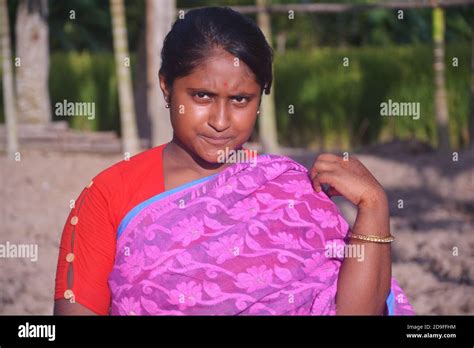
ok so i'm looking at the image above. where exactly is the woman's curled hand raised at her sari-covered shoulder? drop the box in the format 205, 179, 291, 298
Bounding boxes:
311, 154, 387, 207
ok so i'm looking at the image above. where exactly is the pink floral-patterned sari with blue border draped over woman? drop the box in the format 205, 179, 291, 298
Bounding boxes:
109, 155, 413, 315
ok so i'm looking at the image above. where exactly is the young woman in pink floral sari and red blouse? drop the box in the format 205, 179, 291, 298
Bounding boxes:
54, 8, 412, 315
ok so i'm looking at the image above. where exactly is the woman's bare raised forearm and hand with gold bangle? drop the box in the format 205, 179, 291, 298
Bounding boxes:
311, 154, 391, 315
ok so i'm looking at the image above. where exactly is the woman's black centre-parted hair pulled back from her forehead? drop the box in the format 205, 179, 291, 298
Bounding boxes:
160, 7, 273, 94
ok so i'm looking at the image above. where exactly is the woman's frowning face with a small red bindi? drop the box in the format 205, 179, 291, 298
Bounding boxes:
160, 50, 261, 163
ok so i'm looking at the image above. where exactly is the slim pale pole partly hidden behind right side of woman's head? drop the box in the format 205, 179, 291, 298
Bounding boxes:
257, 0, 279, 153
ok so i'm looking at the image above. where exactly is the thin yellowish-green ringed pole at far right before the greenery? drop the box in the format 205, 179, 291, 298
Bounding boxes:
433, 7, 450, 151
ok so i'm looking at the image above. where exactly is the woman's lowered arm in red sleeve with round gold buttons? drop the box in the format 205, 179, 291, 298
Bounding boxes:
54, 167, 121, 315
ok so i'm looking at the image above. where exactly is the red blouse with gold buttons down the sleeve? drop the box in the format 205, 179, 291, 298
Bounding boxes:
54, 144, 166, 315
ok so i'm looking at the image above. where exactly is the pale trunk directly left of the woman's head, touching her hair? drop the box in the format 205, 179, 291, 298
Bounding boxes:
146, 0, 176, 146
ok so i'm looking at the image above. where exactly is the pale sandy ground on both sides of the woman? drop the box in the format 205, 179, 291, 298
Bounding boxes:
0, 143, 474, 314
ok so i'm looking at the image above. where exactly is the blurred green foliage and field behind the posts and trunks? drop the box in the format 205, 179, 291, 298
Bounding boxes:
0, 0, 474, 148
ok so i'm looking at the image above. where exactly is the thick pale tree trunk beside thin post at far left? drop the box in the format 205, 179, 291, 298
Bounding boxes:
15, 0, 51, 125
